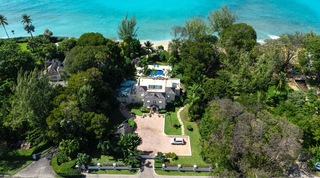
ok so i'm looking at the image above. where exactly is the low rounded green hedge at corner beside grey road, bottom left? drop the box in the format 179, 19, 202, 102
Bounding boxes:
51, 157, 81, 176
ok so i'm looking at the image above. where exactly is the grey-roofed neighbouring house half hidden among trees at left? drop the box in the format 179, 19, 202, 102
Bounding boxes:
45, 60, 63, 82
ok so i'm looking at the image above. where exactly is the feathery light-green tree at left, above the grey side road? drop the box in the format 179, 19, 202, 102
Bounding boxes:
7, 70, 54, 142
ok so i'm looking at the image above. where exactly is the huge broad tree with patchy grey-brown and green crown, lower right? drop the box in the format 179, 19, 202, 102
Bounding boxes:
200, 99, 302, 177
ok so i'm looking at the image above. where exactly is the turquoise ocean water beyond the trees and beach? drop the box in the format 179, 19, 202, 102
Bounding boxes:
0, 0, 320, 40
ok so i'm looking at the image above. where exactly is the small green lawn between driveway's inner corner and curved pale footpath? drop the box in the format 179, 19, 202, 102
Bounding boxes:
164, 108, 181, 135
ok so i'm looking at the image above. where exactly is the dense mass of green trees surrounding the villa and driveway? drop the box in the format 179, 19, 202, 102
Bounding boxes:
0, 6, 320, 177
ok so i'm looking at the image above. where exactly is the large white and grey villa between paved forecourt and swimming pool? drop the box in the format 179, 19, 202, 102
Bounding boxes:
117, 66, 180, 109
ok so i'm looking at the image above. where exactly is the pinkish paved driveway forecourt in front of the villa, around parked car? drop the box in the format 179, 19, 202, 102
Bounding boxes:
135, 114, 191, 156
